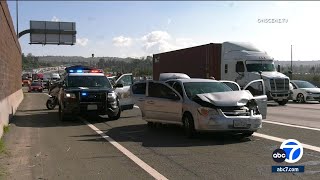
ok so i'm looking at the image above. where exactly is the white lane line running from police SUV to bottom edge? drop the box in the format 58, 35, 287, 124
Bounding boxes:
81, 118, 167, 180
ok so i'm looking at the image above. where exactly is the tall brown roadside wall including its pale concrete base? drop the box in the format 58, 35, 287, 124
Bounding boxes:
0, 0, 23, 138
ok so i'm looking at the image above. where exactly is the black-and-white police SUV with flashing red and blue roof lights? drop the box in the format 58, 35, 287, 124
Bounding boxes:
58, 66, 121, 121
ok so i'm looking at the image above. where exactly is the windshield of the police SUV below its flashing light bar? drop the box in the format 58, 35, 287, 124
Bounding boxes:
67, 76, 112, 88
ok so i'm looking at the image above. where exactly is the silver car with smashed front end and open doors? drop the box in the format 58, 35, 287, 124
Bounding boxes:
131, 78, 267, 137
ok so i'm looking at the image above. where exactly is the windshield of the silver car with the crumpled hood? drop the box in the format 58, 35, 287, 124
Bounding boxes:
183, 82, 232, 99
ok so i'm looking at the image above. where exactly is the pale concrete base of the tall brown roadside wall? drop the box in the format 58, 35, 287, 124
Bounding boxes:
0, 89, 23, 137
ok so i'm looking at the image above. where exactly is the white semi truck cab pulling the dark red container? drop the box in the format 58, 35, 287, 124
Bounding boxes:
221, 42, 290, 105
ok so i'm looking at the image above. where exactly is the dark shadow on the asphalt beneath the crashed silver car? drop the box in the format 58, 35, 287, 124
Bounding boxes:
76, 124, 251, 147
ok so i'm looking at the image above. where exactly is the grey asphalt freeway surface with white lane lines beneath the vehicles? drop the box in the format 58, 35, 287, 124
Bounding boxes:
0, 90, 320, 180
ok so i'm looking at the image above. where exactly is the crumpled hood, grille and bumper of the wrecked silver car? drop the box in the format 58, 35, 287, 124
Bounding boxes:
194, 91, 262, 132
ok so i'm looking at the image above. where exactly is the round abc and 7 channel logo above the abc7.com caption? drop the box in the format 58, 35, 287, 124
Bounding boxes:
272, 139, 303, 163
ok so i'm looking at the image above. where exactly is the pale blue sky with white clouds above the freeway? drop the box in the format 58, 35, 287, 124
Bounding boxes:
8, 1, 320, 60
